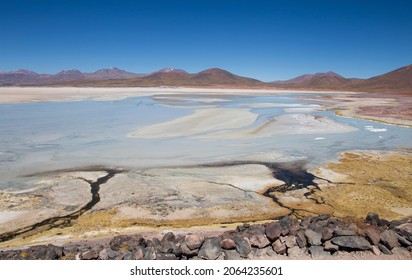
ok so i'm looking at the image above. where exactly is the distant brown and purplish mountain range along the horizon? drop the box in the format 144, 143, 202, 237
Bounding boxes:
0, 65, 412, 94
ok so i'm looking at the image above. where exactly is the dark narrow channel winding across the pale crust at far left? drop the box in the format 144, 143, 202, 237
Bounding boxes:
0, 169, 123, 242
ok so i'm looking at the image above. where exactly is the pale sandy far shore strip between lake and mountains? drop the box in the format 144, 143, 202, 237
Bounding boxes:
0, 86, 412, 127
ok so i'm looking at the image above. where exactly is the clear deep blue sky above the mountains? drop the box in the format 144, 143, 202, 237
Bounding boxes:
0, 0, 412, 81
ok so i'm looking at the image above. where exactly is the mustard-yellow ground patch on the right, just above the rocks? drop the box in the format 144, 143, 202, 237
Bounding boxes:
322, 152, 412, 219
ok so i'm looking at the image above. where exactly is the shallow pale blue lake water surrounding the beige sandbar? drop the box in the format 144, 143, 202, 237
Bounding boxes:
0, 93, 412, 189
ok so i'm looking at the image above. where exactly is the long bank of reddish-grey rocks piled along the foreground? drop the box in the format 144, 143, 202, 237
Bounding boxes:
0, 213, 412, 260
